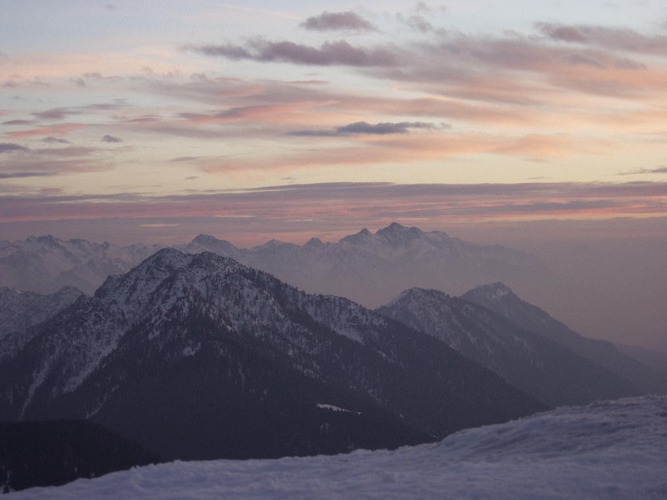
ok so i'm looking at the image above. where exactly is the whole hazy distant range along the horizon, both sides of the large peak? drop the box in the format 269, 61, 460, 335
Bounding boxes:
0, 223, 553, 307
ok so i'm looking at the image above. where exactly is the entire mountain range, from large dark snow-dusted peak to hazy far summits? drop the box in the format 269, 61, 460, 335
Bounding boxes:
0, 224, 667, 459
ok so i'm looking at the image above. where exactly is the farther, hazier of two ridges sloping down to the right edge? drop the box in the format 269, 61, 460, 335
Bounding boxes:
462, 283, 667, 393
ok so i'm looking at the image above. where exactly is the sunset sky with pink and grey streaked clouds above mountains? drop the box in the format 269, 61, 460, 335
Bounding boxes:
0, 0, 667, 352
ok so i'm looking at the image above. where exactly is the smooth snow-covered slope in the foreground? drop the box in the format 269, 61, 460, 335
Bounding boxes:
8, 396, 667, 499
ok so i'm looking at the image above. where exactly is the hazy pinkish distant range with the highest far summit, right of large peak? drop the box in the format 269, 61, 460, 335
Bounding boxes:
182, 223, 553, 307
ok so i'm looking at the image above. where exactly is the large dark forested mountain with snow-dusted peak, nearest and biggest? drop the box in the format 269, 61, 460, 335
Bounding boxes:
0, 249, 544, 459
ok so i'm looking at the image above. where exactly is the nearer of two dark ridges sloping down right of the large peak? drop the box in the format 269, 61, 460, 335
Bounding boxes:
378, 288, 639, 406
